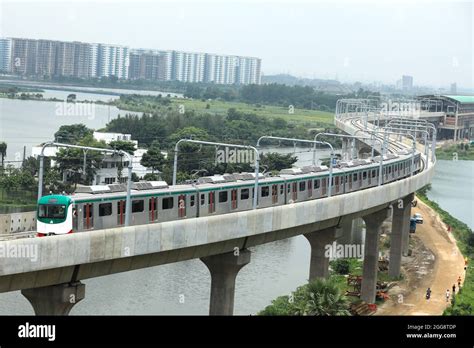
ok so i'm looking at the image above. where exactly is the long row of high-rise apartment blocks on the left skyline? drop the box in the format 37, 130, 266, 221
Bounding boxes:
0, 38, 261, 84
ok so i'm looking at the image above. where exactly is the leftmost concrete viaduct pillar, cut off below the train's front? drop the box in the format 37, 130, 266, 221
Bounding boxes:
21, 282, 86, 315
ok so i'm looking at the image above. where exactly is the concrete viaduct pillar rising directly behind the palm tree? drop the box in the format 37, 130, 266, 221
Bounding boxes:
304, 227, 336, 281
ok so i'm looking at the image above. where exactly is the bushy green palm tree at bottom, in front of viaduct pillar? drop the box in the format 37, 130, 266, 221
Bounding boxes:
290, 278, 350, 316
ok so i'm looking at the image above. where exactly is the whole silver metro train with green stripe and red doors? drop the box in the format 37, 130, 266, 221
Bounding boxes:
37, 149, 423, 236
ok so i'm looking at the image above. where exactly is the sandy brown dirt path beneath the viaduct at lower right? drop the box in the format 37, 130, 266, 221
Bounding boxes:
376, 200, 465, 315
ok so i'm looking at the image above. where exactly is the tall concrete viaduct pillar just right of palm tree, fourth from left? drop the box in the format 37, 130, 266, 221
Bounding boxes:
360, 209, 388, 303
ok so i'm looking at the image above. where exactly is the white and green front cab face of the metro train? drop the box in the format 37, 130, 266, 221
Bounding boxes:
36, 195, 73, 237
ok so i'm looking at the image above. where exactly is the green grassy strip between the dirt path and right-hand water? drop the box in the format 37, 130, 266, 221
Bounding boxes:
416, 185, 474, 315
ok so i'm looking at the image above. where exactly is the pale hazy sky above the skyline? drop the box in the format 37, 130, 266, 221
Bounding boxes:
0, 0, 474, 89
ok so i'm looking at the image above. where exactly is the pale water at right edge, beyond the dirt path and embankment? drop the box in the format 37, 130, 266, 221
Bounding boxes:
428, 160, 474, 230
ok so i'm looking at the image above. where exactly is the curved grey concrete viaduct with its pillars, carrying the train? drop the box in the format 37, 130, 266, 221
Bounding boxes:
0, 105, 434, 315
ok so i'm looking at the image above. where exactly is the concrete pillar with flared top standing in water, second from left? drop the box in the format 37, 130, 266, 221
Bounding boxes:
201, 249, 250, 315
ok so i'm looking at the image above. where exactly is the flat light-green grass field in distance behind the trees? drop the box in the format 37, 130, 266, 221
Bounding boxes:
172, 98, 334, 124
